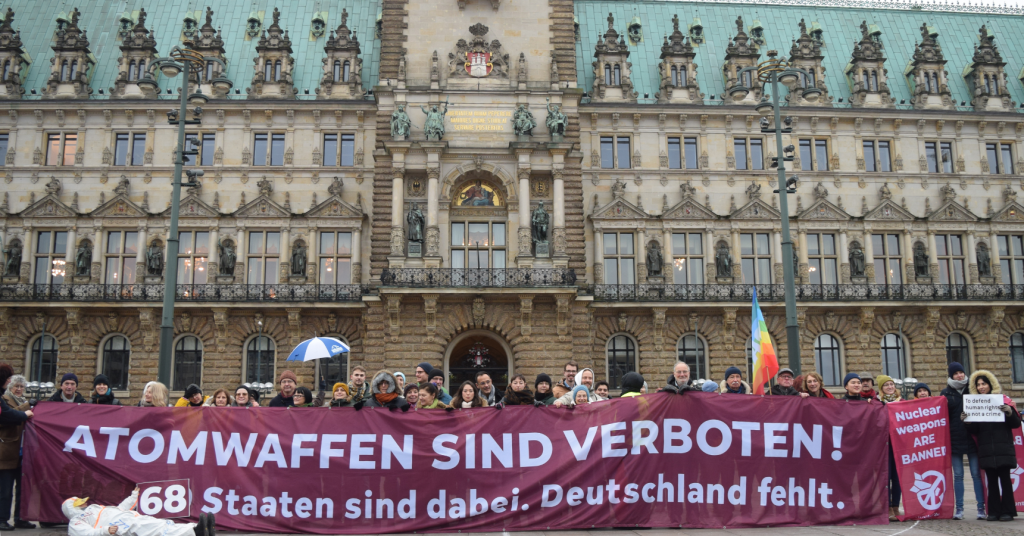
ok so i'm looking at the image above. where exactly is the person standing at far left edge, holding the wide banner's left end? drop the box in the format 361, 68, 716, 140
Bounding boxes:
0, 363, 36, 531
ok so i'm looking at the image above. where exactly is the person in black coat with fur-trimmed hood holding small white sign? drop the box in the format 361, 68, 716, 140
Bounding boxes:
961, 370, 1021, 521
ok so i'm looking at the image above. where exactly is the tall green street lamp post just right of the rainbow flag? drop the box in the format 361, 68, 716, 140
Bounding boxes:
739, 50, 821, 376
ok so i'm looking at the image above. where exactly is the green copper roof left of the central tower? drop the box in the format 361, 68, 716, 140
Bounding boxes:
2, 0, 380, 98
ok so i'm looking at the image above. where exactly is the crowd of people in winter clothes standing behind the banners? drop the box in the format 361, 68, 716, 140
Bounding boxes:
0, 361, 1021, 531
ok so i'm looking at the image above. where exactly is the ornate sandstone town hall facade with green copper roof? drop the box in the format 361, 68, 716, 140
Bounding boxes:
0, 0, 1024, 399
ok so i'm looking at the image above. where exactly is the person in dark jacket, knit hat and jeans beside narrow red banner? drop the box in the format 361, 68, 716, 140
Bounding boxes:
939, 361, 986, 520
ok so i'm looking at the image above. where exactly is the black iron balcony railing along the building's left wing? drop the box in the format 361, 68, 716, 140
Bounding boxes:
0, 284, 367, 303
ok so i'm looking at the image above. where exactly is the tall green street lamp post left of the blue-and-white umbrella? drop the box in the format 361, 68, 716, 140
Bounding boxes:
139, 41, 224, 384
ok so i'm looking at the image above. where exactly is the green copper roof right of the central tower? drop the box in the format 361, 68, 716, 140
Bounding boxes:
575, 0, 1024, 107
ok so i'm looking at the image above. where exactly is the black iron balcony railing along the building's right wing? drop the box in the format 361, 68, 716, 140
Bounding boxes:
594, 284, 1024, 302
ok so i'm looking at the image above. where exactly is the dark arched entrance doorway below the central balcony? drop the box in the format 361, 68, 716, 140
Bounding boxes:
444, 329, 512, 393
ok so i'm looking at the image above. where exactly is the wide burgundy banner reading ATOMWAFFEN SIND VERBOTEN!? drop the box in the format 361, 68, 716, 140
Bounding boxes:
23, 393, 888, 534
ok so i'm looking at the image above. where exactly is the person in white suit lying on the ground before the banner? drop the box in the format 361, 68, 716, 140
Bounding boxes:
60, 488, 216, 536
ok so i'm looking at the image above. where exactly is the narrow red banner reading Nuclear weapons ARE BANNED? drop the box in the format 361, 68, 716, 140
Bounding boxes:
886, 397, 959, 521
